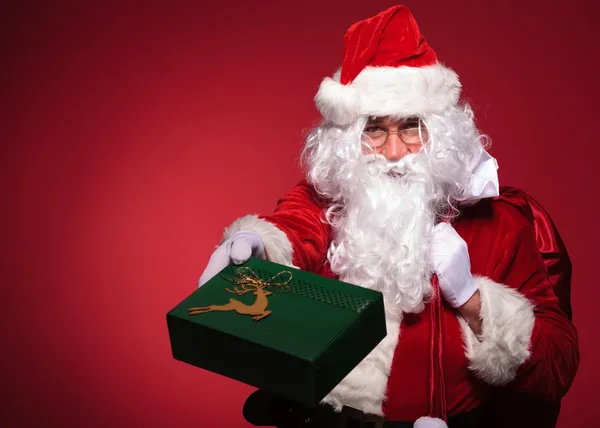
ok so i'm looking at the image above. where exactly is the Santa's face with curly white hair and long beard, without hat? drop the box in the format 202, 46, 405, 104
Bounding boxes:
303, 108, 482, 312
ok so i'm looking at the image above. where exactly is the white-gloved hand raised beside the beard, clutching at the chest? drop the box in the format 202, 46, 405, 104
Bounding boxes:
428, 223, 477, 308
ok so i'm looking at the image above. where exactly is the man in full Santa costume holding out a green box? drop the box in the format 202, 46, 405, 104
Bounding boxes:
200, 6, 579, 428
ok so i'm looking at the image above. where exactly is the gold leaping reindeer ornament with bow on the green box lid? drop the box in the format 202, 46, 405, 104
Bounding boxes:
188, 267, 292, 321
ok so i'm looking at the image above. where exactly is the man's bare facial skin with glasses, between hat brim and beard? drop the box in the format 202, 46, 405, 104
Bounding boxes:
362, 116, 427, 161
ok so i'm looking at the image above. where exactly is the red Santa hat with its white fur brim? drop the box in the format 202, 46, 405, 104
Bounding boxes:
315, 5, 461, 126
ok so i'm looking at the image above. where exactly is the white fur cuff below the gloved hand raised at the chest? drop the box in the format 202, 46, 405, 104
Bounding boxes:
459, 277, 535, 385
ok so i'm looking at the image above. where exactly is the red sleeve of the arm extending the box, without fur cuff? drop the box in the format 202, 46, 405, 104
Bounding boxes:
259, 180, 330, 273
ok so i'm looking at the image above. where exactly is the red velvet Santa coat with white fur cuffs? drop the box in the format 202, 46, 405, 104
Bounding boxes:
224, 181, 579, 427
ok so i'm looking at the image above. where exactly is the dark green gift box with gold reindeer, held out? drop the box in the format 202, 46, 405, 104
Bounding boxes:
167, 258, 386, 405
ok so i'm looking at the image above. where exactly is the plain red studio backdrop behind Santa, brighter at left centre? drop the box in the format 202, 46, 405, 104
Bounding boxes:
0, 0, 600, 427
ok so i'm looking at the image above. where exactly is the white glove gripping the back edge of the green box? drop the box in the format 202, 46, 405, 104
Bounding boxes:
198, 230, 265, 287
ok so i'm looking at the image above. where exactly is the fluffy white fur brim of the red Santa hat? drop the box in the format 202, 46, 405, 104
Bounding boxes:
315, 63, 461, 126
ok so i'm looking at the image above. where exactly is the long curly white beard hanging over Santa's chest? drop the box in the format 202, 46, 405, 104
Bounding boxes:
328, 154, 435, 315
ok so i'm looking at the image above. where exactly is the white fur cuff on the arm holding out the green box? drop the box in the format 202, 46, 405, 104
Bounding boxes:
222, 214, 296, 267
